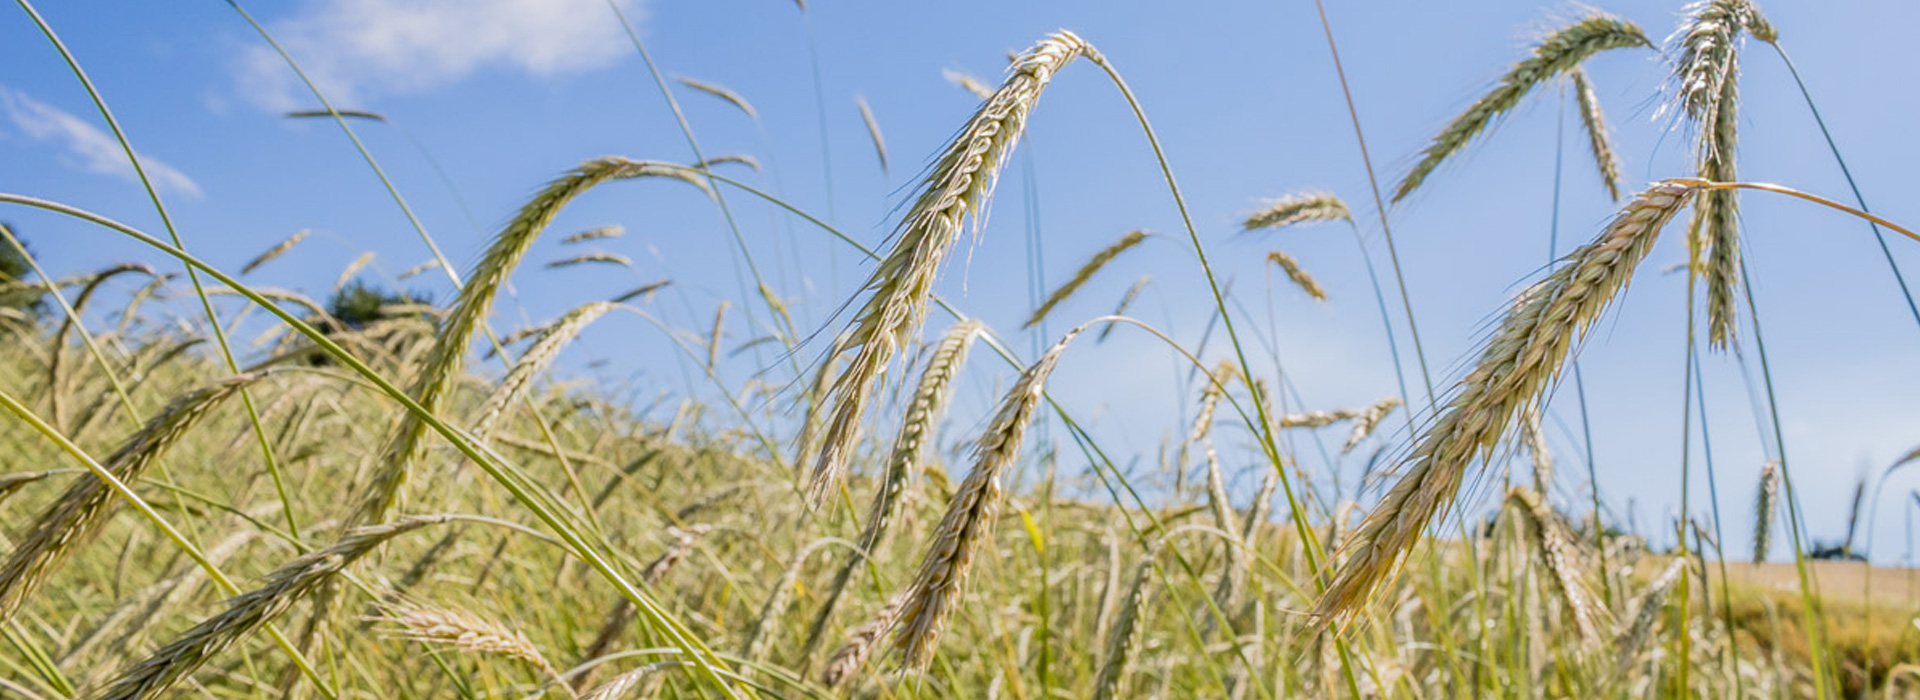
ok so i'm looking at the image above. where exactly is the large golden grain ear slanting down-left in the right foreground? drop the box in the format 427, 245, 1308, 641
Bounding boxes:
1317, 182, 1693, 616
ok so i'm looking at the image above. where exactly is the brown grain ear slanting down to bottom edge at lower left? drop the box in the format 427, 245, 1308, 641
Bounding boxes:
88, 516, 447, 700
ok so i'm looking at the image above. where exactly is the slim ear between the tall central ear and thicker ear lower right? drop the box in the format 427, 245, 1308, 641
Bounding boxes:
806, 320, 987, 648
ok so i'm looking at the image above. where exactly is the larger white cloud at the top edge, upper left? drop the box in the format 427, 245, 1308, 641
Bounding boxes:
238, 0, 639, 109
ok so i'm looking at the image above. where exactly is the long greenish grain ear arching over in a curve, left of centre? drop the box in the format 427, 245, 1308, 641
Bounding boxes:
348, 157, 710, 525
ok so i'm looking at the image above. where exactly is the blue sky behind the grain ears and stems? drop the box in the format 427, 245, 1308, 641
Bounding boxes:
0, 0, 1920, 560
